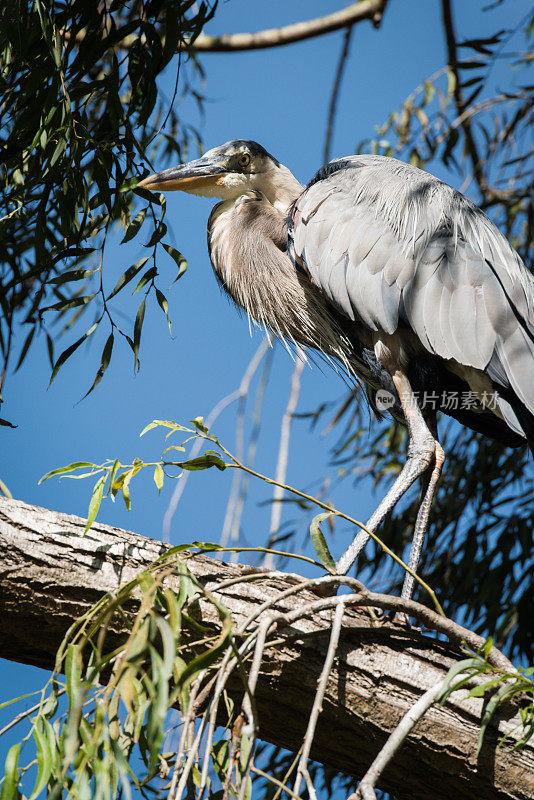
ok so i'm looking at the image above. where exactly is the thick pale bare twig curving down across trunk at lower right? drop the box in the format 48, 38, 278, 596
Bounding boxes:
347, 674, 468, 800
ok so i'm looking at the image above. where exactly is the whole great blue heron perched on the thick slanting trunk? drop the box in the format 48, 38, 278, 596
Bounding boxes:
138, 139, 534, 598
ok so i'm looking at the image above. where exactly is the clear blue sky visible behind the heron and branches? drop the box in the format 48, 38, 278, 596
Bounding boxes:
0, 0, 530, 780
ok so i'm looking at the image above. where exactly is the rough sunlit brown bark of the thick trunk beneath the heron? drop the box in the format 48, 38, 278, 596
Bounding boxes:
0, 499, 534, 800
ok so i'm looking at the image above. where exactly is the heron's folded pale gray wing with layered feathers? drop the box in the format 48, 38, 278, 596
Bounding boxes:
290, 156, 534, 424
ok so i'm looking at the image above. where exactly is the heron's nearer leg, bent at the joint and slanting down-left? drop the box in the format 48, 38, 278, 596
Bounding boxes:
336, 370, 443, 577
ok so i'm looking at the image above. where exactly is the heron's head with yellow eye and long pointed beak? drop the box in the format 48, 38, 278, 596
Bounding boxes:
137, 139, 302, 211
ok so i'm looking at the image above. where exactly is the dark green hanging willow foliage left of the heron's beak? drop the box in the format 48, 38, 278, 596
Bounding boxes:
0, 0, 208, 406
